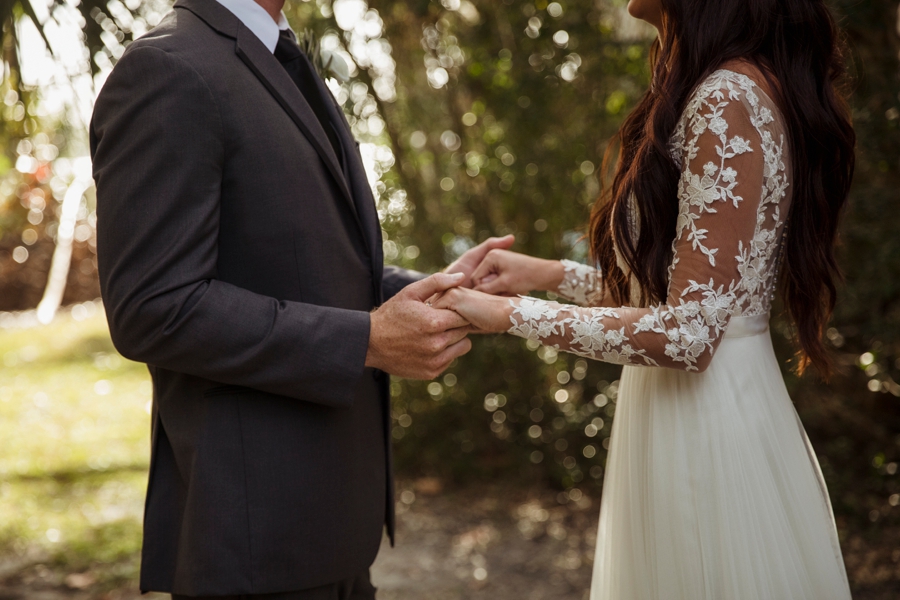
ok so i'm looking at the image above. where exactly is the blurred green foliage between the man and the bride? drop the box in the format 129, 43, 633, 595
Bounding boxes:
356, 1, 649, 487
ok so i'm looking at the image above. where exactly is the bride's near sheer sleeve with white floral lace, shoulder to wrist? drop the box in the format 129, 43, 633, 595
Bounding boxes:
509, 81, 771, 371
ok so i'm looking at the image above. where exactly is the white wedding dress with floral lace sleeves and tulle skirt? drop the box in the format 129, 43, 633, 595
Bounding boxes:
509, 70, 850, 600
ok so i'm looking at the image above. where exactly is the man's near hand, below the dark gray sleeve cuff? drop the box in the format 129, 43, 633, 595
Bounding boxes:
366, 273, 472, 379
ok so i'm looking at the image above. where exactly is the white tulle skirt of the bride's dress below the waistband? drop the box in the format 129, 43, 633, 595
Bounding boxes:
591, 316, 850, 600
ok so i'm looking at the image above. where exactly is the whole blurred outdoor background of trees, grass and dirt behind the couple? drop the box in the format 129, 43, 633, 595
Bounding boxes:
0, 0, 900, 600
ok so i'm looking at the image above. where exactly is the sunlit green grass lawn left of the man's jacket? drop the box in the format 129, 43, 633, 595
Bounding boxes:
0, 303, 151, 590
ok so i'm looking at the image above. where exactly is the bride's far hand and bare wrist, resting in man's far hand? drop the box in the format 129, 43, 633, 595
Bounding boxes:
472, 249, 565, 296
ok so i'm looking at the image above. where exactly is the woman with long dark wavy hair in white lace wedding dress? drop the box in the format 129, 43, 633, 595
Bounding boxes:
436, 0, 852, 600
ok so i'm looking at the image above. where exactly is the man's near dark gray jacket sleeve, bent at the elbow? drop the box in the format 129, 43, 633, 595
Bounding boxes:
91, 42, 369, 407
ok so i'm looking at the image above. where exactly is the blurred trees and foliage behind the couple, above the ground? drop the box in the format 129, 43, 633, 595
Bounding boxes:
0, 0, 900, 572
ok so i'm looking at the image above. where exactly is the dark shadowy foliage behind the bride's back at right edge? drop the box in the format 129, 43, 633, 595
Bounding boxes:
783, 0, 900, 540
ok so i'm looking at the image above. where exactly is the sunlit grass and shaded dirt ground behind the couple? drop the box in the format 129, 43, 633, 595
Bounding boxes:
0, 303, 900, 600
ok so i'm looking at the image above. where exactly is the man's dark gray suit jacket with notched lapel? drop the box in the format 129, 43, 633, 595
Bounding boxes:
91, 0, 419, 595
